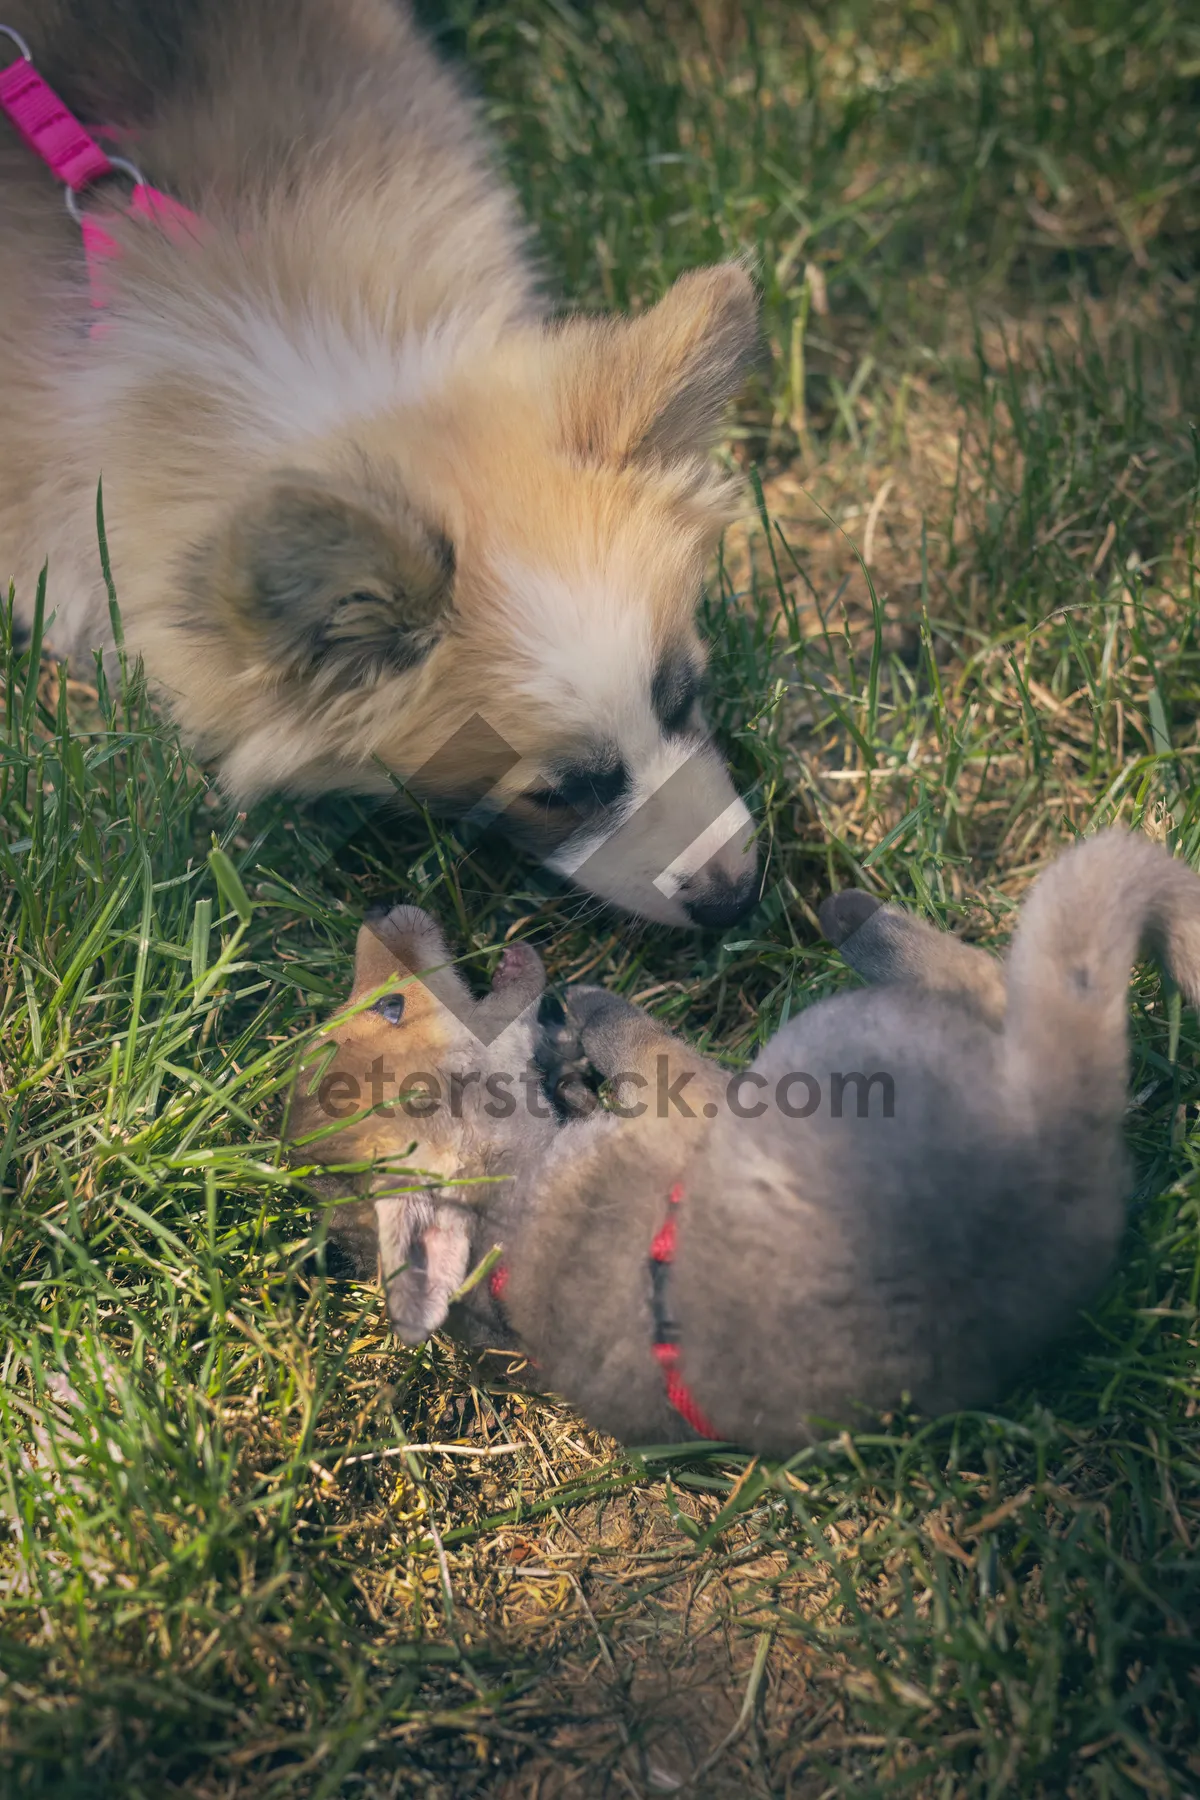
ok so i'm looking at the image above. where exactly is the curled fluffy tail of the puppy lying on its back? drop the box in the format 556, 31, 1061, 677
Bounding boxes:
1004, 830, 1200, 1136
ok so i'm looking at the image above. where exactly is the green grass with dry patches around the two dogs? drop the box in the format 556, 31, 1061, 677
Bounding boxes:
0, 0, 1200, 1800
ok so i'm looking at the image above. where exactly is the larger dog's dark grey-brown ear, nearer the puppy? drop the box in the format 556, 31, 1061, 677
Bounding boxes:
204, 473, 453, 688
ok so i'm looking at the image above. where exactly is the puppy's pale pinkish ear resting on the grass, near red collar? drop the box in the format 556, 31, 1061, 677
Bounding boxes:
374, 1193, 471, 1345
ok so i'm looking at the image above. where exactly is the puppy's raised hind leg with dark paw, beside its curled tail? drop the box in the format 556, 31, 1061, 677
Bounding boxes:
819, 887, 1004, 1028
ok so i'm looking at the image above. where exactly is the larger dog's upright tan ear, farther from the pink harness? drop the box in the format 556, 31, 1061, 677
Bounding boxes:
560, 263, 761, 466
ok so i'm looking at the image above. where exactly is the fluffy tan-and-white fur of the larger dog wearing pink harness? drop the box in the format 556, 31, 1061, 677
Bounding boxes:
0, 0, 756, 923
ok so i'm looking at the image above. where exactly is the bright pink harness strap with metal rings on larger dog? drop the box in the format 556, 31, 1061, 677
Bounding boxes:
0, 25, 205, 337
